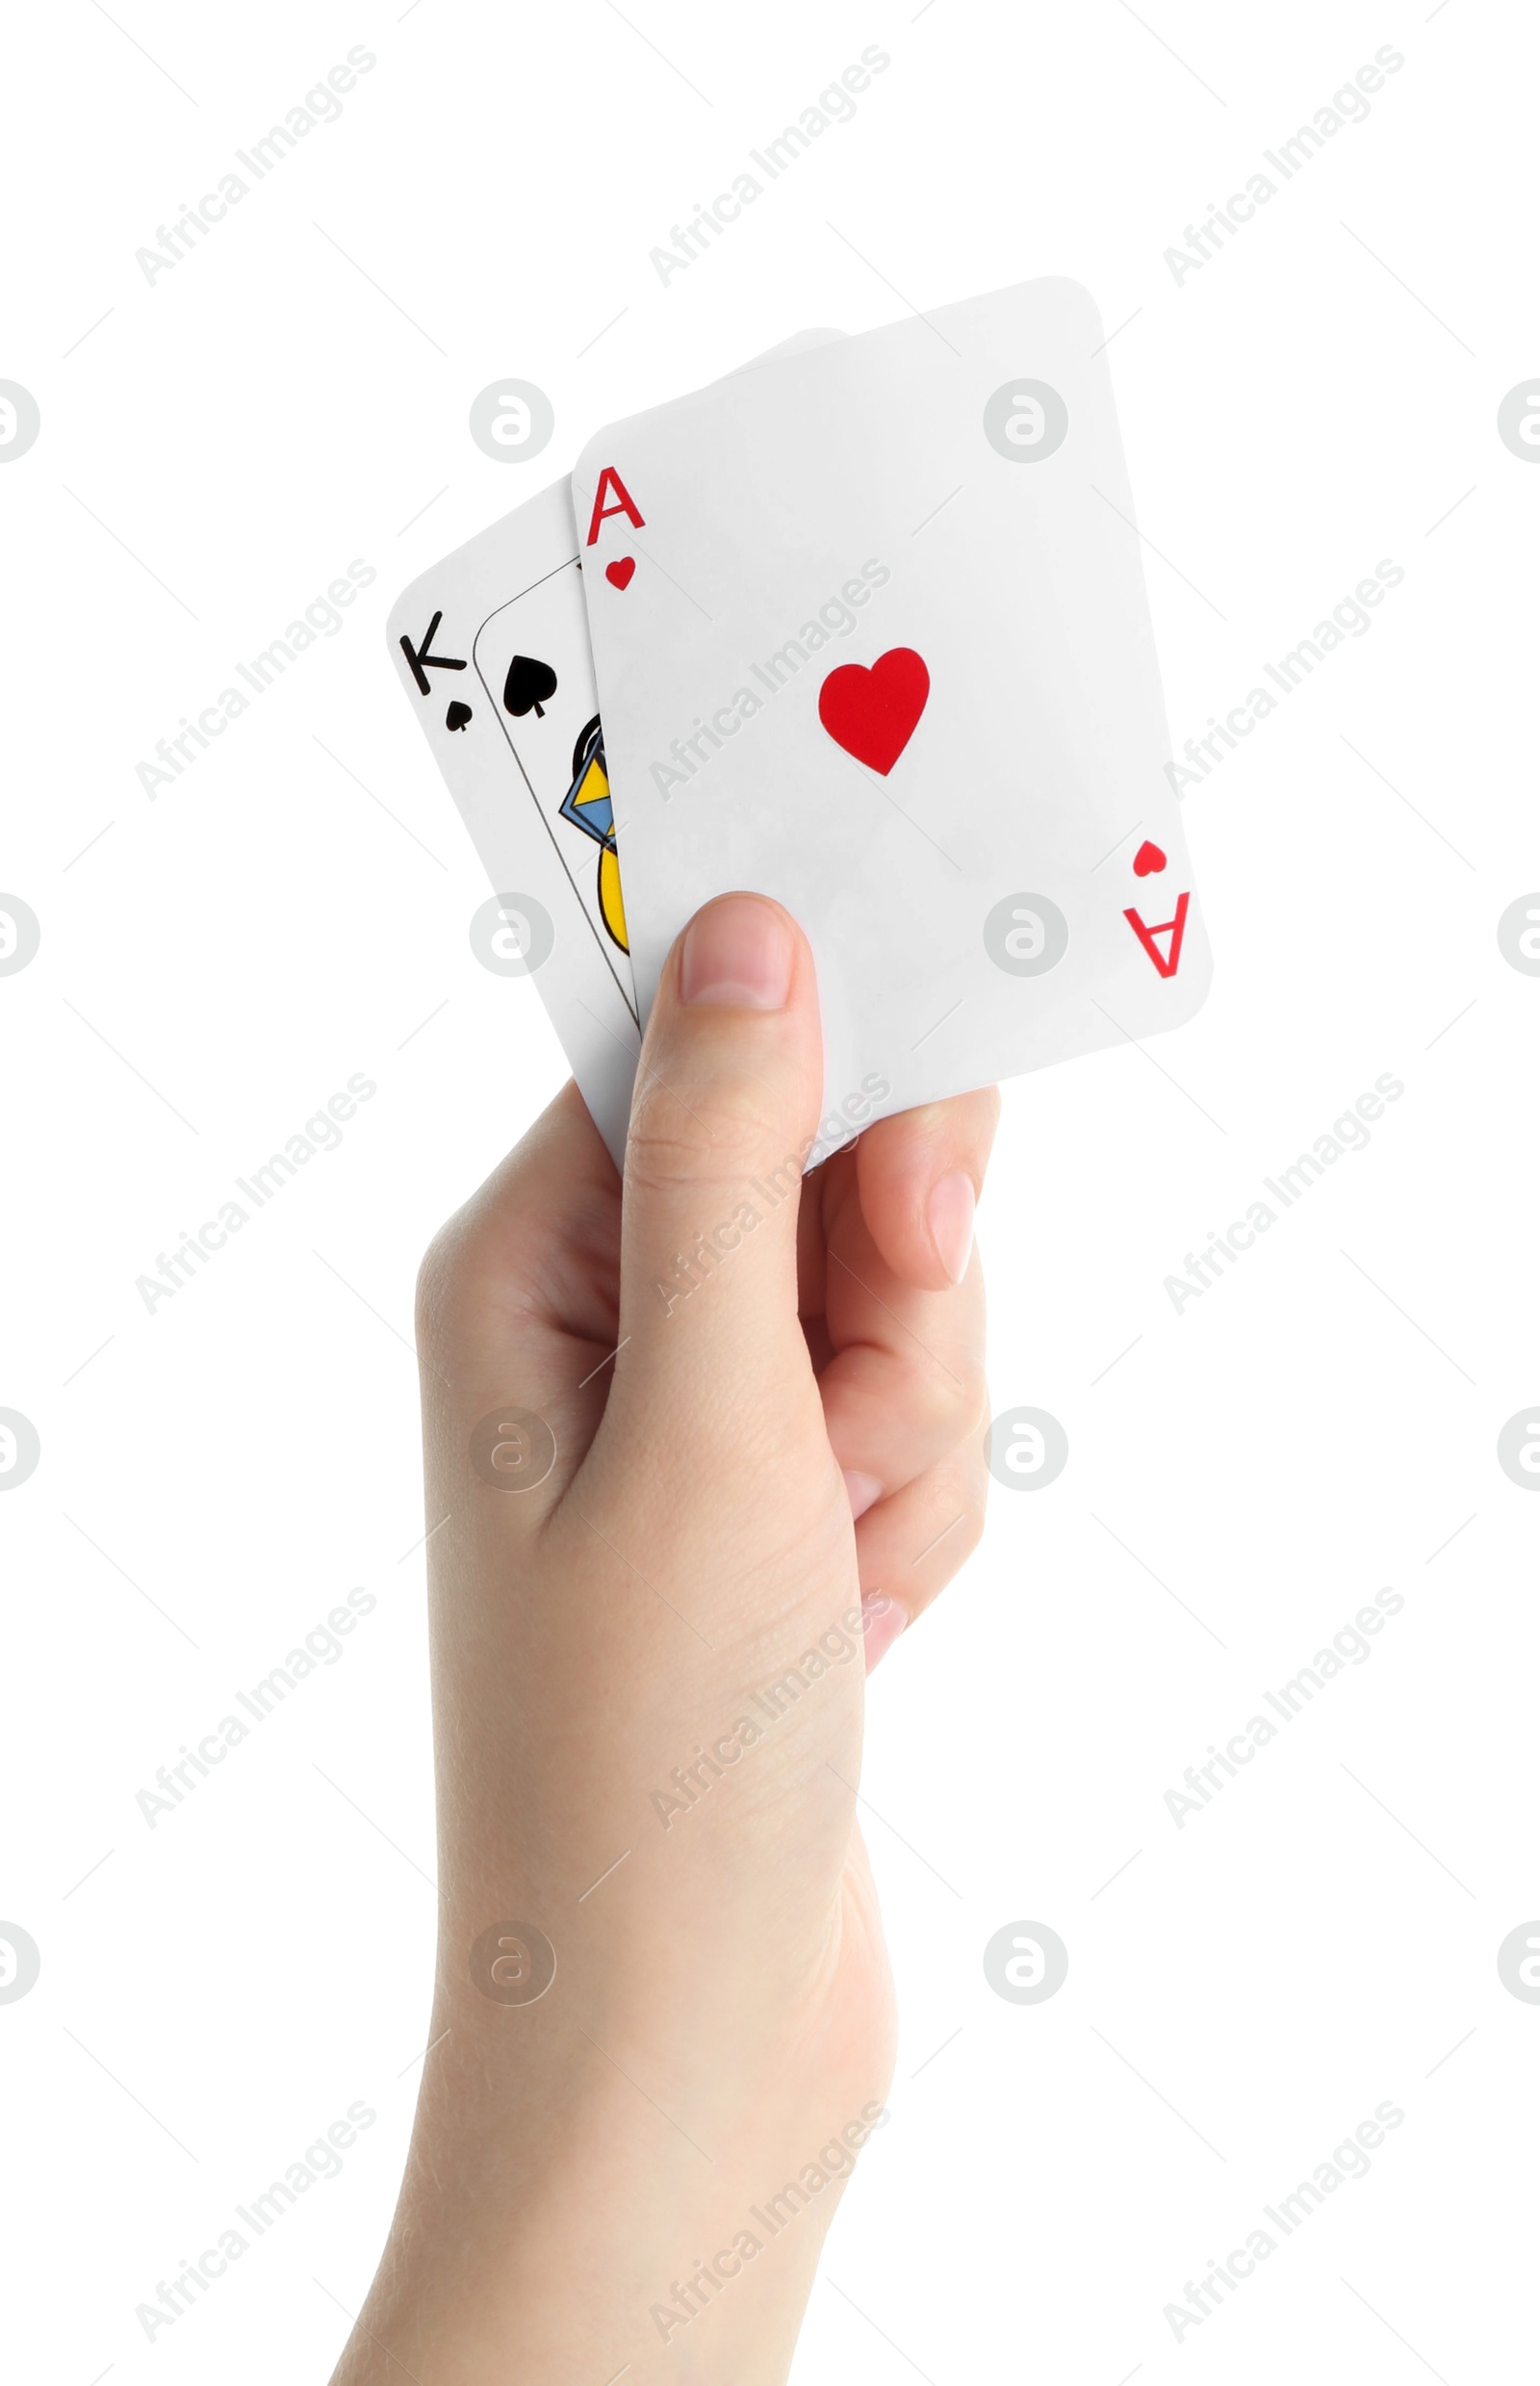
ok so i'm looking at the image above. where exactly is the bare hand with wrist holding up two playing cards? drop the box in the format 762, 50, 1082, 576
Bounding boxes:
337, 895, 995, 2386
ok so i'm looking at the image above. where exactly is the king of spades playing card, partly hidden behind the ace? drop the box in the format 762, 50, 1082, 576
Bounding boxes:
387, 329, 840, 1162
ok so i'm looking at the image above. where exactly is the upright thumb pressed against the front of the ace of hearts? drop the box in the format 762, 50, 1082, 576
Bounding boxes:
606, 895, 824, 1475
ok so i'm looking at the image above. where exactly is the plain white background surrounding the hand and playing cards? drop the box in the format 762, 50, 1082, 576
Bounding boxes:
0, 0, 1540, 2386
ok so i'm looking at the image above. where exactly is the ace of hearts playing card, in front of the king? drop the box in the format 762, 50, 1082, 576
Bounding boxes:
573, 279, 1211, 1150
